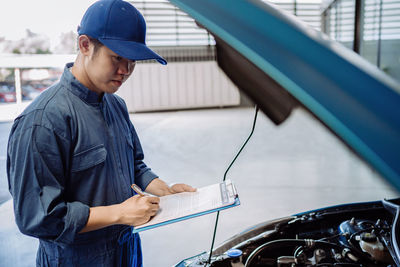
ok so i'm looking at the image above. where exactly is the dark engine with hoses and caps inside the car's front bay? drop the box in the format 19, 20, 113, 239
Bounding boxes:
243, 217, 393, 267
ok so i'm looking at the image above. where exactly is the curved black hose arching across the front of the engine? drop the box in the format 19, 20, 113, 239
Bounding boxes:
244, 239, 373, 267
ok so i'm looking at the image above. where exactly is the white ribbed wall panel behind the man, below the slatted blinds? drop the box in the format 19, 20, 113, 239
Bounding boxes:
118, 61, 240, 112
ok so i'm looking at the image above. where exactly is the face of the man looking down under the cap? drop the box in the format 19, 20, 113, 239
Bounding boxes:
85, 44, 136, 94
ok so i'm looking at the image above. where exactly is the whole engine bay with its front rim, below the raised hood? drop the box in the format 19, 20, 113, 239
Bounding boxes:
178, 199, 400, 267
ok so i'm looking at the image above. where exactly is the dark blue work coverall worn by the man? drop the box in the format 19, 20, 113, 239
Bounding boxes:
7, 63, 157, 266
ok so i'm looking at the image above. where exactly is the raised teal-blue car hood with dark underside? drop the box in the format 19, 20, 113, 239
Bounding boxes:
170, 0, 400, 191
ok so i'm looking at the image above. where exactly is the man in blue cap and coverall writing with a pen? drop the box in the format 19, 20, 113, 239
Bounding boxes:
7, 0, 195, 267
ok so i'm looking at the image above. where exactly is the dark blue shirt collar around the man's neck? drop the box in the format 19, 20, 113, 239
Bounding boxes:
61, 63, 103, 104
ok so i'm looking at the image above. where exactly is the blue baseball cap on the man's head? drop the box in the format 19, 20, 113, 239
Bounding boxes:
78, 0, 167, 65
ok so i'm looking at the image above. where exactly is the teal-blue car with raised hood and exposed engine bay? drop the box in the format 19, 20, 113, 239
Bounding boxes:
170, 0, 400, 267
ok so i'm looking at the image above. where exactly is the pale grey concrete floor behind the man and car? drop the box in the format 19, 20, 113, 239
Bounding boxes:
0, 108, 399, 267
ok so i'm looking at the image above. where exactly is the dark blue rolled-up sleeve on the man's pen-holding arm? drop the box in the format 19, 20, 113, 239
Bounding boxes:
7, 119, 89, 244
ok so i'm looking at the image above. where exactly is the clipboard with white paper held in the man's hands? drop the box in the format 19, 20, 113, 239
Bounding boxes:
132, 179, 240, 233
